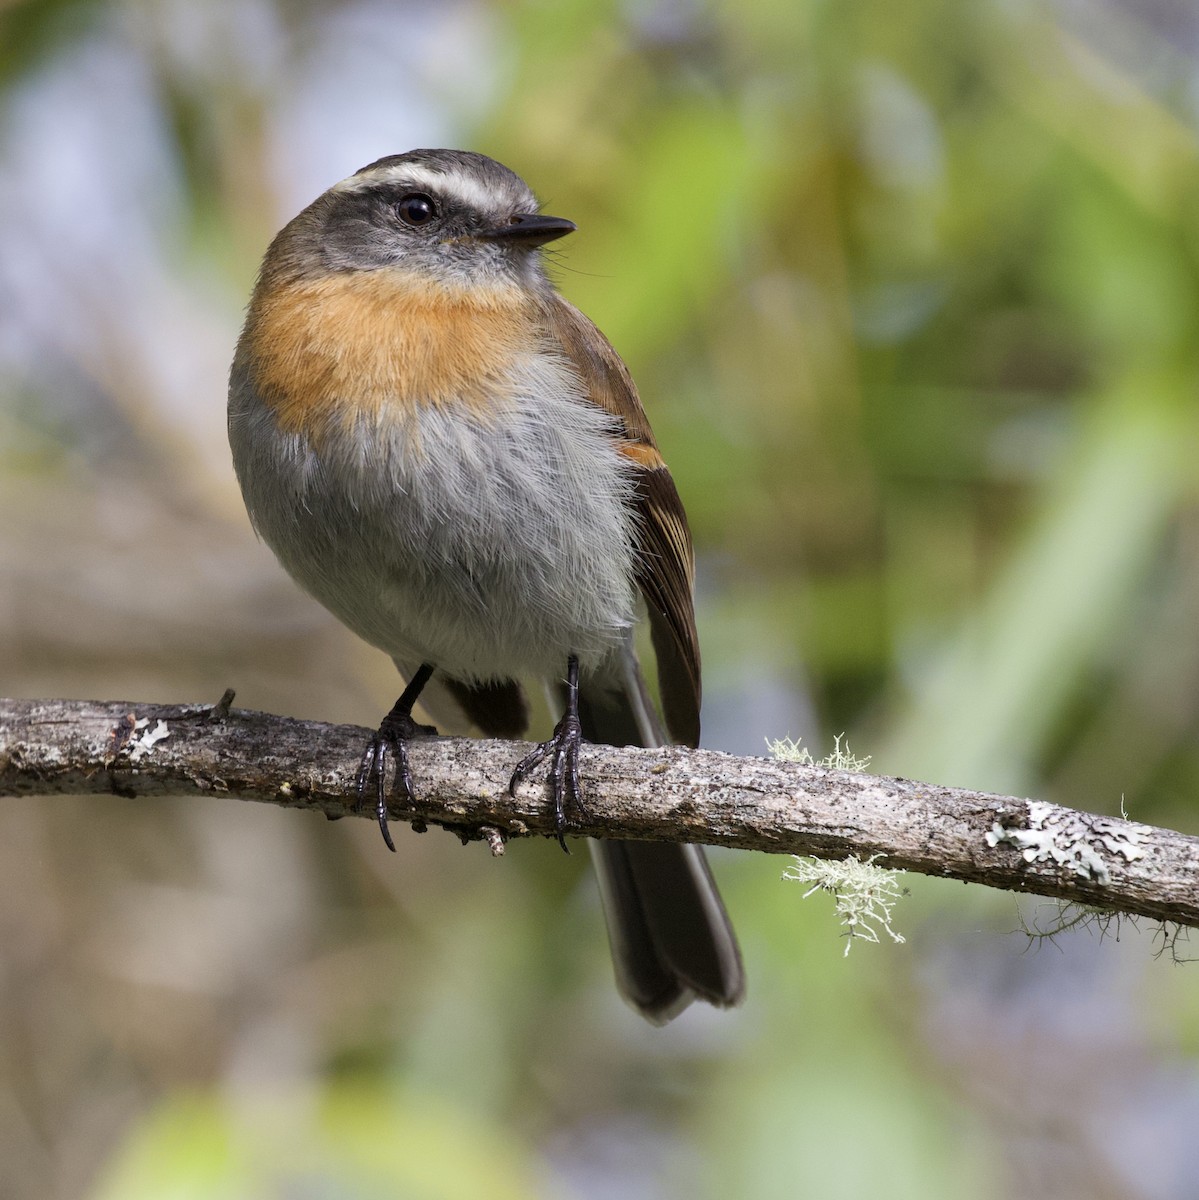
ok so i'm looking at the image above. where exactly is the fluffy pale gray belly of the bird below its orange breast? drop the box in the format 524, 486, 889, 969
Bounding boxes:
229, 378, 635, 679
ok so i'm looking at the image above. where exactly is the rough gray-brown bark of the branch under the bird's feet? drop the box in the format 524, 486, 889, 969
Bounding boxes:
0, 695, 1199, 925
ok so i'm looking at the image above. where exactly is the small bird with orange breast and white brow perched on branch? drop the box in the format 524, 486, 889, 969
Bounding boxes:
228, 149, 744, 1025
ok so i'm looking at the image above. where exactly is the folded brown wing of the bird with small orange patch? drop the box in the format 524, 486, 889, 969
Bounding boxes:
546, 295, 700, 745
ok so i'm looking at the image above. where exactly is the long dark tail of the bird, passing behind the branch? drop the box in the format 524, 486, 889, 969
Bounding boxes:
580, 648, 745, 1025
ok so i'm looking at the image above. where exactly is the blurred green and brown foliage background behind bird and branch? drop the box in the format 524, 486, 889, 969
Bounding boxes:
0, 0, 1199, 1200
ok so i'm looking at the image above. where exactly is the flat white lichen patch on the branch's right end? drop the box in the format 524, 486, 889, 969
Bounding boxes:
987, 800, 1150, 883
